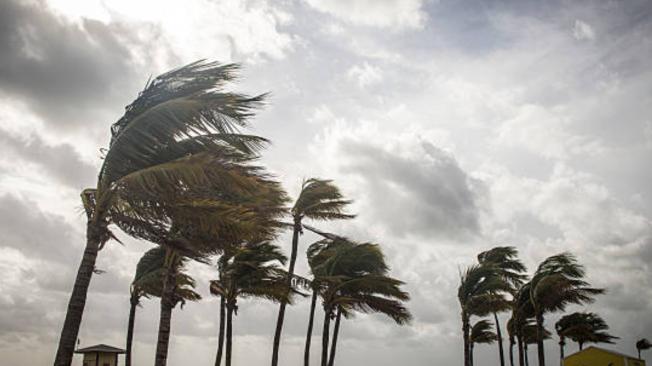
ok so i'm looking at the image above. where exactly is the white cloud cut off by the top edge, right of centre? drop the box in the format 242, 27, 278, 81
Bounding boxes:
307, 0, 427, 29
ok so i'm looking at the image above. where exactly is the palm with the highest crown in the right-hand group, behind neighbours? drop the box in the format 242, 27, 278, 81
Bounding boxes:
478, 246, 527, 366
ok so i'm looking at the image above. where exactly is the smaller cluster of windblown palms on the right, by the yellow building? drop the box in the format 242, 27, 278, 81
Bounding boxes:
458, 246, 618, 366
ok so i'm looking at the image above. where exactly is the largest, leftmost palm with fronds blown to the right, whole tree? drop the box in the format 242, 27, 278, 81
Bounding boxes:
54, 61, 265, 366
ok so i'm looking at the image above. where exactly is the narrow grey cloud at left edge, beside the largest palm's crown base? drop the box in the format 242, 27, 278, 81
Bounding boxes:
0, 131, 96, 189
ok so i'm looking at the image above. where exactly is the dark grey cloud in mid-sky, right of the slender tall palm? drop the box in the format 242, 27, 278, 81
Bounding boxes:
341, 140, 484, 238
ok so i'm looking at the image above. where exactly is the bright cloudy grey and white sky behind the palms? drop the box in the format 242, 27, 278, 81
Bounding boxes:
0, 0, 652, 366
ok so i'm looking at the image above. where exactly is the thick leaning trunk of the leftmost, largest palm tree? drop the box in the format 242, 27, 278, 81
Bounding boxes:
54, 222, 101, 366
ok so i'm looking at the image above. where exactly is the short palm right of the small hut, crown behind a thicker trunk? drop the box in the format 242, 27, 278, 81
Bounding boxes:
125, 247, 201, 366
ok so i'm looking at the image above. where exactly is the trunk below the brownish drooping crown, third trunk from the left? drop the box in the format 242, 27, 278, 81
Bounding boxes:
154, 254, 176, 366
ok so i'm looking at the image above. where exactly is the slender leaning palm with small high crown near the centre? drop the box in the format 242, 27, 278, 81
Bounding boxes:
272, 178, 355, 366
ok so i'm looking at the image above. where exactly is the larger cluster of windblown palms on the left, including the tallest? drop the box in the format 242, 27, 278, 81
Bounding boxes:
54, 61, 411, 366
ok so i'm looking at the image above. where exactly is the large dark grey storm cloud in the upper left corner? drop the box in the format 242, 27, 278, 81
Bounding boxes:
0, 0, 142, 128
